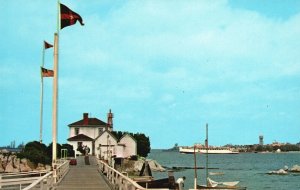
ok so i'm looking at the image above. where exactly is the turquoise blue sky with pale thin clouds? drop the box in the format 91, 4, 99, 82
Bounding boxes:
0, 0, 300, 148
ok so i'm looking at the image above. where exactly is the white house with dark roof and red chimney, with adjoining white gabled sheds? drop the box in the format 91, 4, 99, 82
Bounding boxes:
67, 110, 137, 160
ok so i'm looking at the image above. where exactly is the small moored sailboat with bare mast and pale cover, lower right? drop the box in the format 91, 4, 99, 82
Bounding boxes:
194, 124, 247, 190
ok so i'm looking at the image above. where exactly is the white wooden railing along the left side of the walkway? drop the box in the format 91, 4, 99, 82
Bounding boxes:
0, 160, 69, 190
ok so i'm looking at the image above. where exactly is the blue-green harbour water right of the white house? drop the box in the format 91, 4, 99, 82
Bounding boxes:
148, 150, 300, 190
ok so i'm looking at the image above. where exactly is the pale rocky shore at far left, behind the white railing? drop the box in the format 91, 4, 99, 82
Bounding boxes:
0, 154, 51, 173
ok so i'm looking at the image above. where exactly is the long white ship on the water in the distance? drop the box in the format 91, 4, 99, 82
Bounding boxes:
179, 144, 239, 154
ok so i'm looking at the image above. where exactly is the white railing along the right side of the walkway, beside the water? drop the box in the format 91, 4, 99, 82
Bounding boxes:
98, 160, 167, 190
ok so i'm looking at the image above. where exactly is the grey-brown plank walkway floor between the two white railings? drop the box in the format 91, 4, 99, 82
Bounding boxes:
55, 156, 110, 190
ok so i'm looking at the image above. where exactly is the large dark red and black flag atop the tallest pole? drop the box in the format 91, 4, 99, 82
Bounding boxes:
60, 4, 84, 29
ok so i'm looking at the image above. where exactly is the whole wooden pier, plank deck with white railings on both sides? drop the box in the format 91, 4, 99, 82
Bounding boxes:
0, 156, 166, 190
